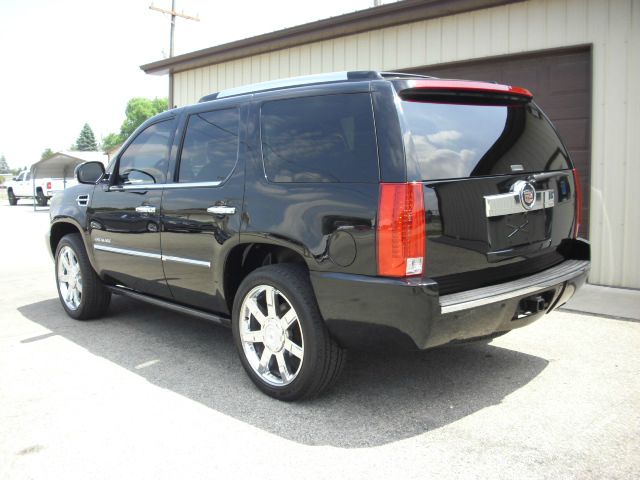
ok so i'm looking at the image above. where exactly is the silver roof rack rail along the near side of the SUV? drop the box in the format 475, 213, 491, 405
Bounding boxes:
199, 70, 382, 103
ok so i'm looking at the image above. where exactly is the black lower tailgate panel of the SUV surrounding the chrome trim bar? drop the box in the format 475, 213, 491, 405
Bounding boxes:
424, 171, 575, 294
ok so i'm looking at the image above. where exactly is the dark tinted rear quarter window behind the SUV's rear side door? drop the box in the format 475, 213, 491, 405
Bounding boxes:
261, 93, 378, 182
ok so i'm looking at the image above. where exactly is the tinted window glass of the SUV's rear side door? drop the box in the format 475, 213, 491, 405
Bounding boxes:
178, 109, 239, 182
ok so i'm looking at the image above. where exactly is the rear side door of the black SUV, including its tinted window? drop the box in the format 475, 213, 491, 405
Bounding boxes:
161, 101, 246, 314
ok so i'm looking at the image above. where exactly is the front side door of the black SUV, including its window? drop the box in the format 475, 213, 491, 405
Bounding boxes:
87, 118, 175, 297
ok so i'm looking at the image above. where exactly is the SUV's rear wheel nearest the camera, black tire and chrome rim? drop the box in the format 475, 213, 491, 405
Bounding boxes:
232, 264, 346, 401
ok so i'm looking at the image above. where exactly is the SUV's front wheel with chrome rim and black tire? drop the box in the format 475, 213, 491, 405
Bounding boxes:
56, 233, 111, 320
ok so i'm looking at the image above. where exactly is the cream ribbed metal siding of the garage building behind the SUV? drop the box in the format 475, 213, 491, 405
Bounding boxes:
174, 0, 640, 288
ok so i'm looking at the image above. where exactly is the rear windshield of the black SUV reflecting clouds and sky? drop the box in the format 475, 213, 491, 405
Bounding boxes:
402, 101, 570, 180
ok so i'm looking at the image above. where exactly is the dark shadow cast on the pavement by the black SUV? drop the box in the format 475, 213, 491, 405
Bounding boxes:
19, 297, 548, 448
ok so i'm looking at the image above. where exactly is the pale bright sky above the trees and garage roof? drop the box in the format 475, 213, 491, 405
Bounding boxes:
0, 0, 391, 168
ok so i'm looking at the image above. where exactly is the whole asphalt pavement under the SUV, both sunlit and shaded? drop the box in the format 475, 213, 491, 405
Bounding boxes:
0, 202, 640, 480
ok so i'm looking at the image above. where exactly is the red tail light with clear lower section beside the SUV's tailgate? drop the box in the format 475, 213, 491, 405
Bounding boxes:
376, 183, 426, 277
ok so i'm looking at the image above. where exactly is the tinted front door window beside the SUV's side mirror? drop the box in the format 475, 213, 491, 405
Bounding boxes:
118, 120, 173, 185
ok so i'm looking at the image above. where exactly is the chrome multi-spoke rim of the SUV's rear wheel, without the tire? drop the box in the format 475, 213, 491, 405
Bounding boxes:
239, 285, 304, 386
